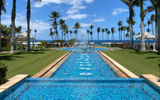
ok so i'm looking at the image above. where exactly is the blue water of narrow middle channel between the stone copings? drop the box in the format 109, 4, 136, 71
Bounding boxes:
51, 52, 118, 79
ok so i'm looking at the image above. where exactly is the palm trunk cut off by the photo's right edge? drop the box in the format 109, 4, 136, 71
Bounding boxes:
157, 7, 160, 54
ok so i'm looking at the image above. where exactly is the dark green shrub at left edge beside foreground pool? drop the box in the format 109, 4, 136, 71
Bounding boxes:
0, 63, 8, 84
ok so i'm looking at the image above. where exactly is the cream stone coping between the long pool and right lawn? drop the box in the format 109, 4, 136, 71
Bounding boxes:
98, 51, 139, 78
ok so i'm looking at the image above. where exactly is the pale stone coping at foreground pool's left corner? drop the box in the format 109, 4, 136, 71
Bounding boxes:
0, 74, 29, 93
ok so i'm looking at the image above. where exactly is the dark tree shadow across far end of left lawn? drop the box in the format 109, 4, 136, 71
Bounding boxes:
0, 51, 45, 61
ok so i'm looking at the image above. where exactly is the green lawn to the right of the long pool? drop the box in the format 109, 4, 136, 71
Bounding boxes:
104, 49, 160, 77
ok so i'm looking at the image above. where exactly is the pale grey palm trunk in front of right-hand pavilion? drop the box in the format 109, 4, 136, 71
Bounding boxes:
141, 18, 145, 50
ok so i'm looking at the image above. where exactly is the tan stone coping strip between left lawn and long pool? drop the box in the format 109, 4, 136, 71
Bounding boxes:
32, 51, 71, 78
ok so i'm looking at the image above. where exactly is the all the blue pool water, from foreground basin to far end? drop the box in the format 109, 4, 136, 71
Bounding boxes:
0, 48, 160, 100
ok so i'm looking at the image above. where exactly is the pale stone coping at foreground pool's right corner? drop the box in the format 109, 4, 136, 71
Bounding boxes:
141, 74, 160, 89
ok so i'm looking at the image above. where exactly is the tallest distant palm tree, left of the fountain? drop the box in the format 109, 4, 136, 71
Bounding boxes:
50, 11, 60, 40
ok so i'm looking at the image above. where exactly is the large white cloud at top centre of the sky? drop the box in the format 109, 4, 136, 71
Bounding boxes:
34, 0, 94, 20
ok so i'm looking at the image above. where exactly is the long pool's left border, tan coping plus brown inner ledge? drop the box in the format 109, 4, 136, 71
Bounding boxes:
32, 51, 71, 78
